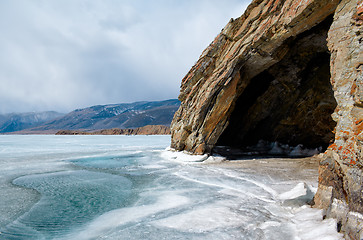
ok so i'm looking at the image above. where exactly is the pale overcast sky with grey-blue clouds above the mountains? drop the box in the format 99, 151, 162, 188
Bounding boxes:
0, 0, 250, 113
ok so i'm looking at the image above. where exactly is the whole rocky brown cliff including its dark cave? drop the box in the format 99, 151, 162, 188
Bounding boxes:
171, 0, 363, 239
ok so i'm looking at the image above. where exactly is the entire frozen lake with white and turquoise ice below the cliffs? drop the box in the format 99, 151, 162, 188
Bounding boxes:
0, 135, 341, 240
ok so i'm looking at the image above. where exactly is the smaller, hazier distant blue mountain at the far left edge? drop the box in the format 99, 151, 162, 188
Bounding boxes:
0, 111, 65, 133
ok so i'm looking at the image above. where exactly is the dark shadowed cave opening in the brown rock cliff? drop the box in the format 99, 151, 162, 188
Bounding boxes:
214, 17, 337, 158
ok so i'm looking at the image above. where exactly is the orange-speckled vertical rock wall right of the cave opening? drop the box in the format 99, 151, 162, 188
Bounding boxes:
315, 1, 363, 239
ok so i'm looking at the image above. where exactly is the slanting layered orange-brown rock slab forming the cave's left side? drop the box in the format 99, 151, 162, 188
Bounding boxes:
172, 0, 339, 154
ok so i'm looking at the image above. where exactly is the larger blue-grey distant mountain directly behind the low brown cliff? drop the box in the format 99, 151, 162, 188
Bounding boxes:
27, 99, 180, 132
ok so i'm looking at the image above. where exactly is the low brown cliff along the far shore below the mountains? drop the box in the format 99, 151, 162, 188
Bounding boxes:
56, 125, 170, 135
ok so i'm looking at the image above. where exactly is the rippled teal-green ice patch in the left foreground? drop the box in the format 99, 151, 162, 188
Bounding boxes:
2, 170, 132, 238
